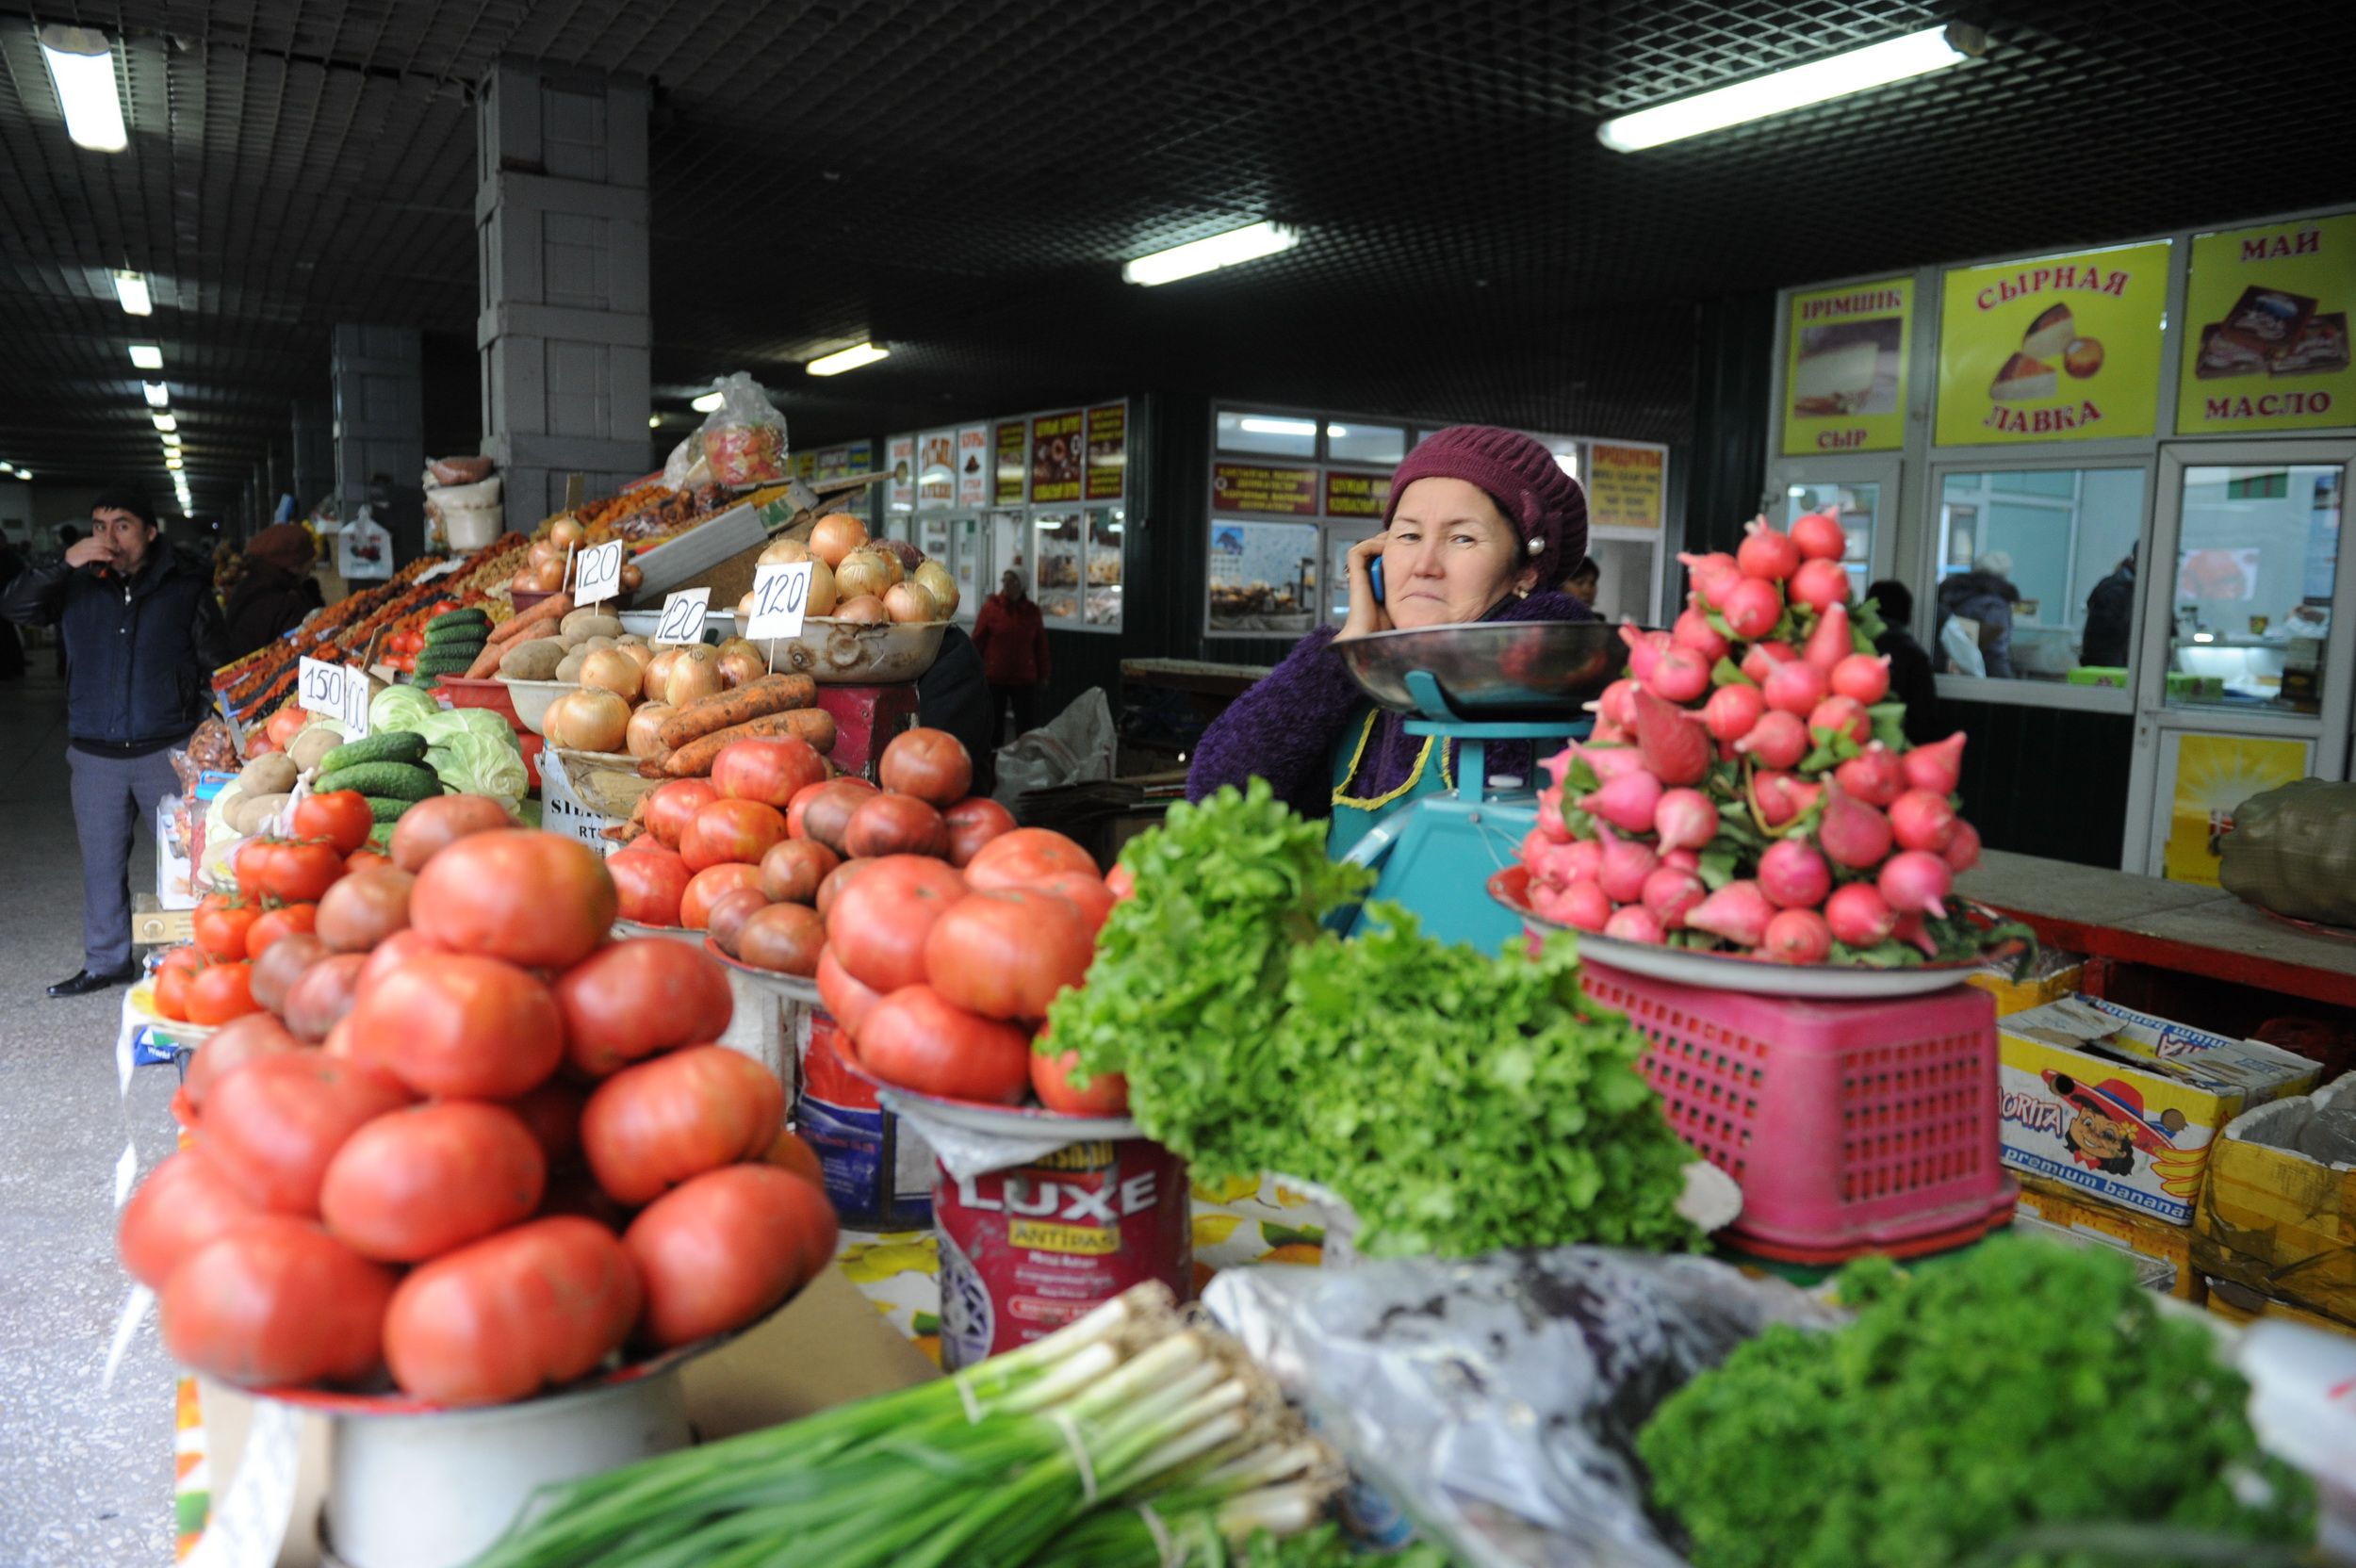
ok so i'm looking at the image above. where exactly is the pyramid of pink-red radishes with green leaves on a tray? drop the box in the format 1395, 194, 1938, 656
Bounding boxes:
1520, 514, 1991, 968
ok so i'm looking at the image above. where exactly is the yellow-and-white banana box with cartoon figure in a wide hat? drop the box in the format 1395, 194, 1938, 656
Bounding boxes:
1996, 996, 2318, 1224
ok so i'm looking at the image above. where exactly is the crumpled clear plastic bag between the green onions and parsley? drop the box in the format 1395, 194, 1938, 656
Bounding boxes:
1204, 1248, 1842, 1568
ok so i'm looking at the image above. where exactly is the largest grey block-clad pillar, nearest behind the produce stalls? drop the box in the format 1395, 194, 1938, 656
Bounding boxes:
474, 61, 653, 530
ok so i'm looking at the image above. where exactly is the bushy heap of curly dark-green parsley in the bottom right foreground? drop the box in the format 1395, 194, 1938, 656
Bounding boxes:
1638, 1238, 2314, 1568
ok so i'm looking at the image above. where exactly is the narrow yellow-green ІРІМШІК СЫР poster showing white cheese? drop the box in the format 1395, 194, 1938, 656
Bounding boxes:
1784, 278, 1913, 457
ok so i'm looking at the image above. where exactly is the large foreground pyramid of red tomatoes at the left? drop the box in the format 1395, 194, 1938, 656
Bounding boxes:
118, 795, 837, 1406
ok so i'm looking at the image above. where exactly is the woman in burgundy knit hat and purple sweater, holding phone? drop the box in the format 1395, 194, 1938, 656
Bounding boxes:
1187, 424, 1595, 855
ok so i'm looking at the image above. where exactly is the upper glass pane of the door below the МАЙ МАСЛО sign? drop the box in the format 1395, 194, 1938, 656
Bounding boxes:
2168, 464, 2342, 713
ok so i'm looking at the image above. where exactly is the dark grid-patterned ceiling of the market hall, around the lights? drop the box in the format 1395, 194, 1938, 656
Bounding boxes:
0, 0, 2356, 511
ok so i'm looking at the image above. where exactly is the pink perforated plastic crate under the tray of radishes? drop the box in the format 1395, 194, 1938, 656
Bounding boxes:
1586, 963, 2020, 1262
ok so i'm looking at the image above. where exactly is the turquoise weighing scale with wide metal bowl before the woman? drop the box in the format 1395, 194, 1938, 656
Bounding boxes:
1333, 622, 1626, 954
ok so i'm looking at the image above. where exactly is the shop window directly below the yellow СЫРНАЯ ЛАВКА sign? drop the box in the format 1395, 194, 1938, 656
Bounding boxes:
1930, 468, 2144, 688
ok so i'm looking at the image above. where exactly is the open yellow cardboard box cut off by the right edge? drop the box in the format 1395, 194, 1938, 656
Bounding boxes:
2194, 1073, 2356, 1326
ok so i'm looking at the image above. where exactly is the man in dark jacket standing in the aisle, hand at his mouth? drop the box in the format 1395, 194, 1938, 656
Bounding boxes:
0, 495, 226, 996
